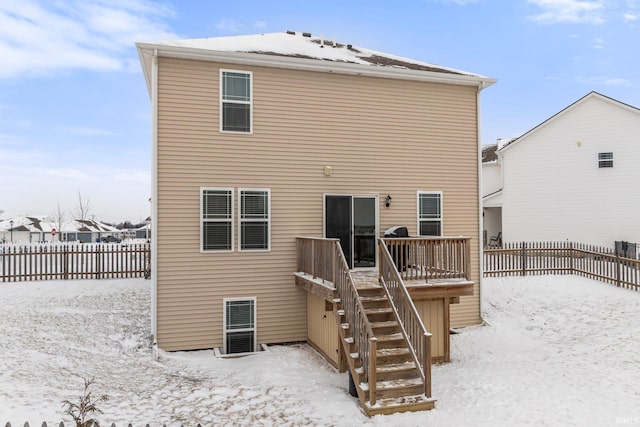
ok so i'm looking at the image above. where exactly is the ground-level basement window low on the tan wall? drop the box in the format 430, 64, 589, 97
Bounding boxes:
224, 298, 256, 354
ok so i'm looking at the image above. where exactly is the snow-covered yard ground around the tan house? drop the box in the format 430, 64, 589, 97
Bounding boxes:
0, 276, 640, 427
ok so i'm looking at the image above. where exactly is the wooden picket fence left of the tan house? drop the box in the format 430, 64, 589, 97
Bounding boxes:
0, 243, 150, 282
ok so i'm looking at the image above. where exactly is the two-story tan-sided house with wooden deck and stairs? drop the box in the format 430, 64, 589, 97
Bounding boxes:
137, 32, 494, 414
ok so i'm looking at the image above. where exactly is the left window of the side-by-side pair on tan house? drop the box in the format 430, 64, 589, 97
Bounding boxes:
200, 188, 233, 251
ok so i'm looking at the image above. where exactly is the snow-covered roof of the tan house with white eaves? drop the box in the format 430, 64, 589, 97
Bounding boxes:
136, 31, 495, 92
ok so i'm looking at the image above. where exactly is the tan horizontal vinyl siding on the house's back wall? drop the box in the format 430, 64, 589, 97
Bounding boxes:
156, 58, 480, 350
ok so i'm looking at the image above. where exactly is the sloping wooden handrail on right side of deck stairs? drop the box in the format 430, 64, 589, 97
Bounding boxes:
378, 239, 431, 397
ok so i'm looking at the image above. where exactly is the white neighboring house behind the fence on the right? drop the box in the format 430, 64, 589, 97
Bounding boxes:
482, 92, 640, 247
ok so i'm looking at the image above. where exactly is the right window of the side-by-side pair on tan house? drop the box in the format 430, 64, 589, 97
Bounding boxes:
239, 188, 271, 250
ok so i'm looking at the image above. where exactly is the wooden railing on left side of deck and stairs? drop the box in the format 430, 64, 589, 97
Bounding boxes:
297, 237, 378, 406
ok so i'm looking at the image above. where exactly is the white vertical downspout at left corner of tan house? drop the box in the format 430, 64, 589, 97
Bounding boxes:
151, 49, 159, 354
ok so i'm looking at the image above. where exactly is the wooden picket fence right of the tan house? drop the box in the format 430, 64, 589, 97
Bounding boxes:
483, 242, 640, 291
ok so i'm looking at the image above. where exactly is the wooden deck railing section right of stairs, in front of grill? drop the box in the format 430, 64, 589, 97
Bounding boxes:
382, 237, 471, 281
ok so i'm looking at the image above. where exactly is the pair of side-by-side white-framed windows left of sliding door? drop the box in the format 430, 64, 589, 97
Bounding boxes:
200, 188, 271, 252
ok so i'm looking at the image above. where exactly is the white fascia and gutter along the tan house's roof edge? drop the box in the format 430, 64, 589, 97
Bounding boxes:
137, 43, 496, 89
